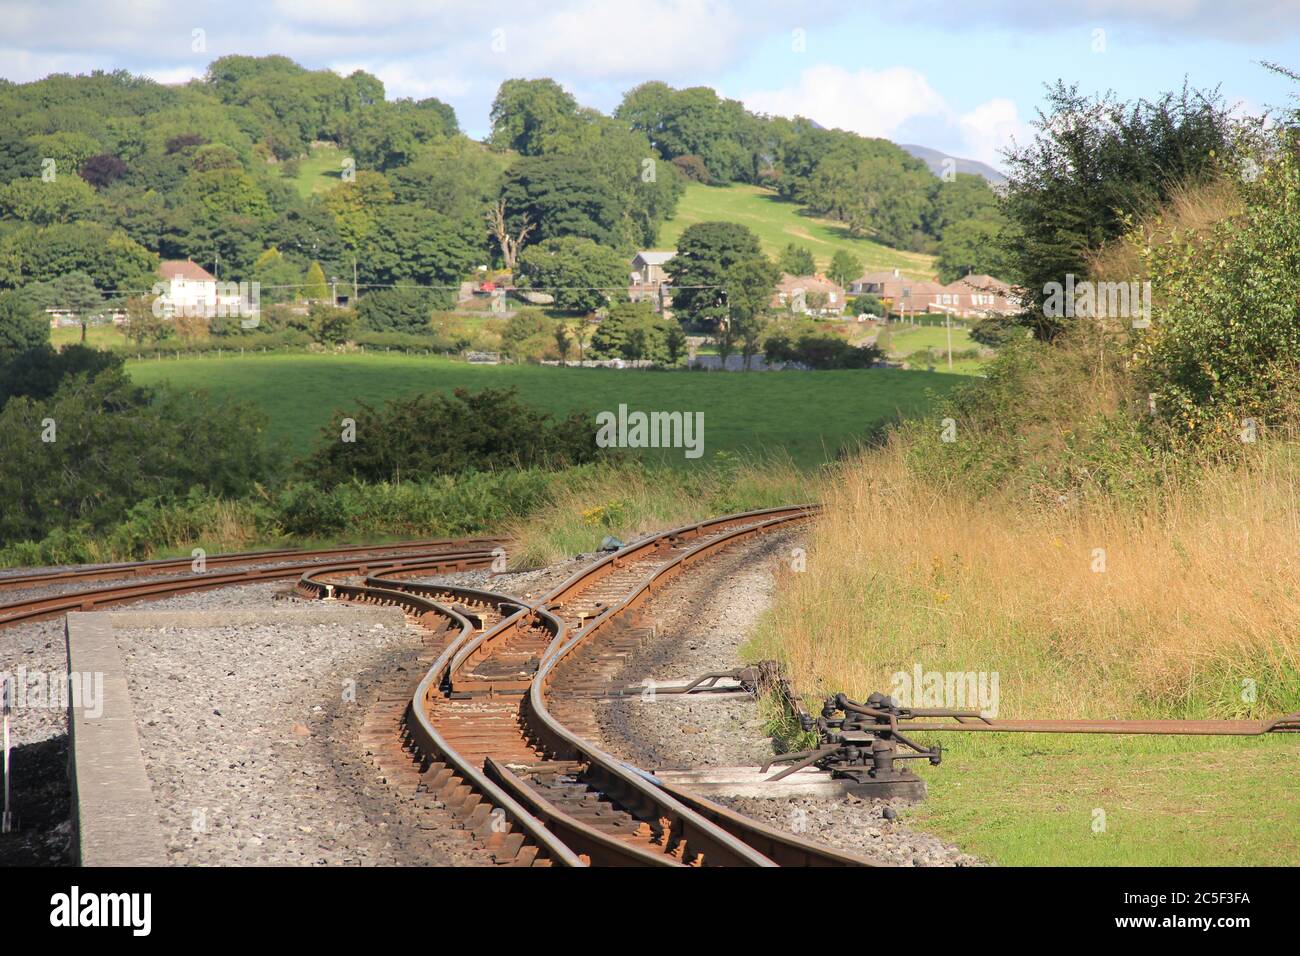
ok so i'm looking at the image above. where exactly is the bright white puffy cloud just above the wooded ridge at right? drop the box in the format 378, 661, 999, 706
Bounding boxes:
742, 64, 1028, 165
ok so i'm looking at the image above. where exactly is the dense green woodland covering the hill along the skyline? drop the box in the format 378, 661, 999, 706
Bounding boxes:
0, 56, 1002, 317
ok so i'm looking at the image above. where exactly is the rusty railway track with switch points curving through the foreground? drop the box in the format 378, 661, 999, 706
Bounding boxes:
298, 506, 870, 866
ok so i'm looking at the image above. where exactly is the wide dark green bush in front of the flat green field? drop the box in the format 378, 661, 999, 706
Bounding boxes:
302, 389, 597, 488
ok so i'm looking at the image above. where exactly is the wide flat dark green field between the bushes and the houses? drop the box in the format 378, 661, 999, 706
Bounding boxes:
127, 354, 959, 467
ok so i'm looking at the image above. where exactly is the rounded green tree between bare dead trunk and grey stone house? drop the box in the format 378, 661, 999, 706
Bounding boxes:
516, 235, 628, 312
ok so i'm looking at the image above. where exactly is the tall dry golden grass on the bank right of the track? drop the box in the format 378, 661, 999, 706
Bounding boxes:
750, 444, 1300, 717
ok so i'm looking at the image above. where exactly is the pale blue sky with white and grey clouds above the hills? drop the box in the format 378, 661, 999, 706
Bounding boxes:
0, 0, 1300, 164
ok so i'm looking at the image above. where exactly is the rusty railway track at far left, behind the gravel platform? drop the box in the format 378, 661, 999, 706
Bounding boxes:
0, 538, 501, 628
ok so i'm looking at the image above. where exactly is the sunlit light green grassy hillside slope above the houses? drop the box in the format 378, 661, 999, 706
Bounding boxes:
657, 182, 935, 278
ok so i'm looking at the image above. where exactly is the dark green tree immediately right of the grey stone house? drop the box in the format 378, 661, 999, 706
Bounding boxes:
664, 222, 762, 326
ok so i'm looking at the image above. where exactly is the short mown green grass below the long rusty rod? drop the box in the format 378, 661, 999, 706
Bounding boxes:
902, 734, 1300, 866
